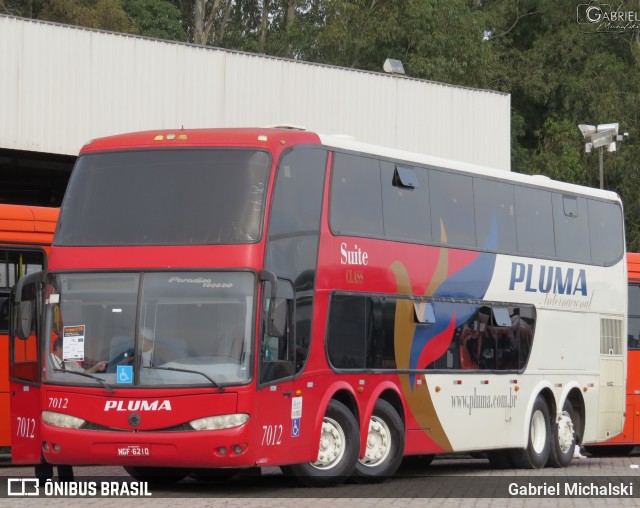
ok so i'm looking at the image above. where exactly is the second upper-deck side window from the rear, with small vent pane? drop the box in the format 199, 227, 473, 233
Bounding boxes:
553, 193, 591, 263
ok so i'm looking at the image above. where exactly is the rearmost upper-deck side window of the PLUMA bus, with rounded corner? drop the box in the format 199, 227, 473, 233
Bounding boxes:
587, 199, 624, 265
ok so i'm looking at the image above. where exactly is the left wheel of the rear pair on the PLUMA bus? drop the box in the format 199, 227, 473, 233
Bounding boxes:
511, 396, 551, 469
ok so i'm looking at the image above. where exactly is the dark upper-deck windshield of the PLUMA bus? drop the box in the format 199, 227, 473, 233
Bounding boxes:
54, 148, 271, 246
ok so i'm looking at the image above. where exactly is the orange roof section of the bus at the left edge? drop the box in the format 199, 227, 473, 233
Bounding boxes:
0, 204, 60, 245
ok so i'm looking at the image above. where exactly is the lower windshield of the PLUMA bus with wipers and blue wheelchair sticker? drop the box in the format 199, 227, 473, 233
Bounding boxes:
45, 272, 255, 388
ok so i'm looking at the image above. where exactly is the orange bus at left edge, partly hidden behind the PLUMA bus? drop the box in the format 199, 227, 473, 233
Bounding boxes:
0, 204, 58, 447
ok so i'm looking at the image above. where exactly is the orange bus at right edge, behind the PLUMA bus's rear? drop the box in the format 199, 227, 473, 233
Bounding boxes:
586, 252, 640, 457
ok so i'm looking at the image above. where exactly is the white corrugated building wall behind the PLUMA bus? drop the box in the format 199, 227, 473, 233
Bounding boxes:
0, 16, 510, 170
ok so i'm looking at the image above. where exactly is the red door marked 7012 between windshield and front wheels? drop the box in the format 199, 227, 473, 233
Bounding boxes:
256, 276, 304, 466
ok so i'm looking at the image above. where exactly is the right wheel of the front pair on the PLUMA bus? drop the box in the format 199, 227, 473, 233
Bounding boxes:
353, 400, 404, 483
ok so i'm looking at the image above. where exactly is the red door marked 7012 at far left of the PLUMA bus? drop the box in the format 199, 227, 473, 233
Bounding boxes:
9, 272, 44, 464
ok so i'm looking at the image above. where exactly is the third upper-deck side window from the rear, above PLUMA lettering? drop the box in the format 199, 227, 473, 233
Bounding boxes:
515, 185, 556, 257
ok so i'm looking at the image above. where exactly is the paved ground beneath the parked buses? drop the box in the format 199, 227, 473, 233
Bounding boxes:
0, 455, 640, 508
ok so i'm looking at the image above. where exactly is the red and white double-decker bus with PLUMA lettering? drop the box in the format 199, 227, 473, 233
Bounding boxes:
11, 129, 627, 485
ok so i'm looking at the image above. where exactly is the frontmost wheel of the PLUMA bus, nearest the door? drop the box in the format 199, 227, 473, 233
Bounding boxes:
280, 400, 360, 487
